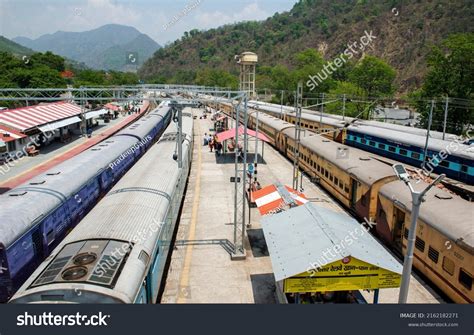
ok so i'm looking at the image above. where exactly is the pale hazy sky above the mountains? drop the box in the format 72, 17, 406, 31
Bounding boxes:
0, 0, 296, 45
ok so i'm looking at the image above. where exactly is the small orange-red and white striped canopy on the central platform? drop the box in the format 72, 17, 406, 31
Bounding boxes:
253, 185, 308, 215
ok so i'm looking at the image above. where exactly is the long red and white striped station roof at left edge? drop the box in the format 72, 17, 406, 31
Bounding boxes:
0, 102, 81, 132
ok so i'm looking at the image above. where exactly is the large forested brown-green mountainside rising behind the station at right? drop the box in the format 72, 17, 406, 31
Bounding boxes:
139, 0, 474, 92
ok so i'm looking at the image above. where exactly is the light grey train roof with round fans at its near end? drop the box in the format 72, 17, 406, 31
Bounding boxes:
13, 109, 193, 303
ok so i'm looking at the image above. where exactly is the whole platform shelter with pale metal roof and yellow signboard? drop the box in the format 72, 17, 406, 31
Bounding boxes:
261, 202, 402, 303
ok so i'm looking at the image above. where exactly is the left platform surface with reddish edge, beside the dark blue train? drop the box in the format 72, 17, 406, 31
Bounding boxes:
0, 104, 148, 194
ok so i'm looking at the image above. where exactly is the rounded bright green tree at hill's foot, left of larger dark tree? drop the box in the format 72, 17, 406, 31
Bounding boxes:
349, 56, 396, 97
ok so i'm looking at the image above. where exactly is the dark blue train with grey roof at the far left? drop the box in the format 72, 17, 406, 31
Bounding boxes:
0, 103, 171, 302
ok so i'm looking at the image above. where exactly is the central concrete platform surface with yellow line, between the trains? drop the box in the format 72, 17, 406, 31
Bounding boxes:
161, 110, 441, 303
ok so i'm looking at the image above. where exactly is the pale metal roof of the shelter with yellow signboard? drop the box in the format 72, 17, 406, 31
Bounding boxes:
261, 203, 402, 281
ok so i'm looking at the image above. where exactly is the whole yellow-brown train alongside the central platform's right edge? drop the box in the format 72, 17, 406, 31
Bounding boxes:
216, 100, 474, 303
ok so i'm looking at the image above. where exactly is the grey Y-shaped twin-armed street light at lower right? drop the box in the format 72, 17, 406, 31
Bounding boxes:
393, 164, 446, 304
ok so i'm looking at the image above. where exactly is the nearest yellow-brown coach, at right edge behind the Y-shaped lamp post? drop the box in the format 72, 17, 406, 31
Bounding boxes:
376, 181, 474, 303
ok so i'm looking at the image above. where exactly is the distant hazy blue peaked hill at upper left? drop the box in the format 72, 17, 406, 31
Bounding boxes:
13, 24, 160, 71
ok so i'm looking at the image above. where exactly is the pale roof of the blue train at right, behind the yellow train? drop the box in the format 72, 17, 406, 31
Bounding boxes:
349, 124, 474, 160
